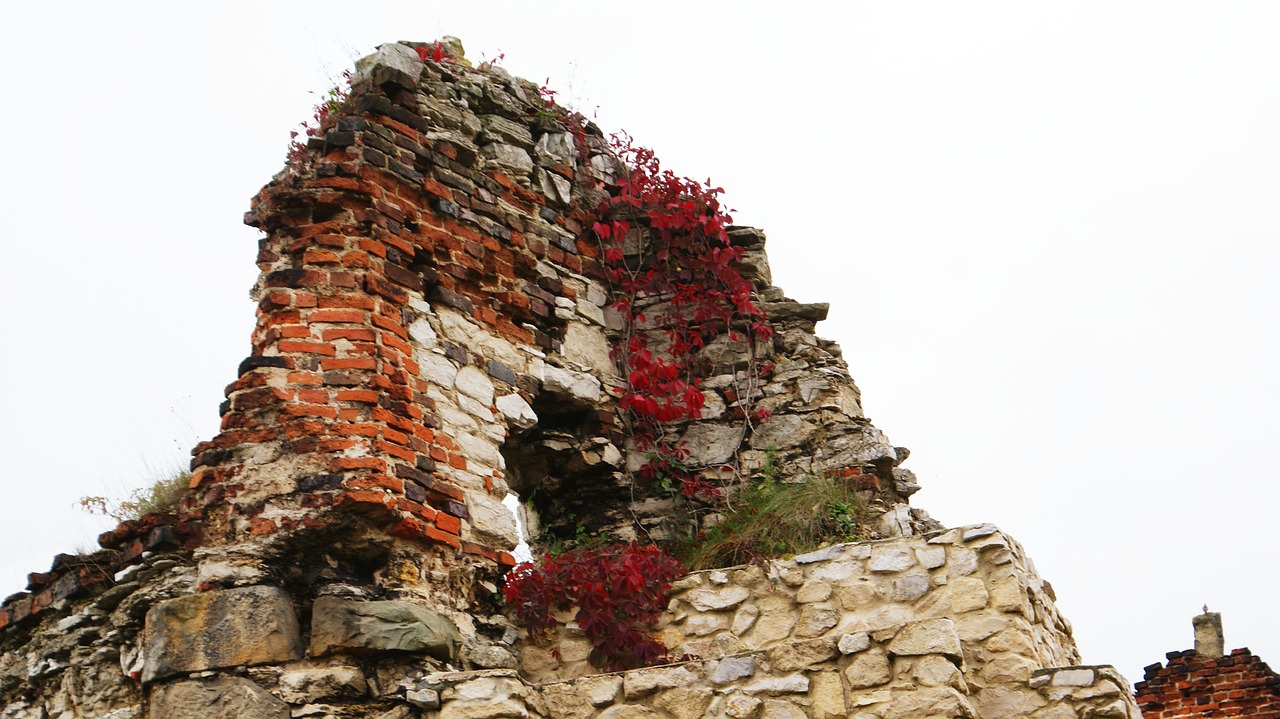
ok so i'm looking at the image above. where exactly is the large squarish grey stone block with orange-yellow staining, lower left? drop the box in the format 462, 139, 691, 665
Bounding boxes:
142, 586, 302, 683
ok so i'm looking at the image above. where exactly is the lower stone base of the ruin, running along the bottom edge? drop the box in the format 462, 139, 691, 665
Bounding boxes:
0, 526, 1139, 719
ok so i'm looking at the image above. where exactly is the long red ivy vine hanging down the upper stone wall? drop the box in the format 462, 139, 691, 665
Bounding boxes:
591, 134, 773, 499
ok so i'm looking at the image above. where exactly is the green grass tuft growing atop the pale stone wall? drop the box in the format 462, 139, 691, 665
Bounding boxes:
675, 452, 863, 569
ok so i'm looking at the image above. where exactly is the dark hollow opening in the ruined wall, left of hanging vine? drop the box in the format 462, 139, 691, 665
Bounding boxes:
502, 391, 632, 547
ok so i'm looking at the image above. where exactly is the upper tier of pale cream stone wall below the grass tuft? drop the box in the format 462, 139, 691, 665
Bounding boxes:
521, 525, 1080, 686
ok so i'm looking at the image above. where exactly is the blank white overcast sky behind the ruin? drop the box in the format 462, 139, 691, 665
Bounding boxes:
0, 0, 1280, 681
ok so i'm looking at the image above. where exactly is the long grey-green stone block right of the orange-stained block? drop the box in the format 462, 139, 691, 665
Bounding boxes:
311, 596, 462, 661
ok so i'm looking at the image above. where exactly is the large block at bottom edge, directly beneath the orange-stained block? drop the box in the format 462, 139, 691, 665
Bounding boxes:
148, 677, 289, 719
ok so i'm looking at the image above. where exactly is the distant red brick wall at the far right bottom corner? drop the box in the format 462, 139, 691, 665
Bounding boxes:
1134, 649, 1280, 719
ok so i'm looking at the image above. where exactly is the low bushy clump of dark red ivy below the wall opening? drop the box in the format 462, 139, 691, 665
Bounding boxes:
502, 541, 685, 672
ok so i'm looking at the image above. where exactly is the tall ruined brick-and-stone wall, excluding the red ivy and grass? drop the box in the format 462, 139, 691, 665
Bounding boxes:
0, 37, 1141, 719
